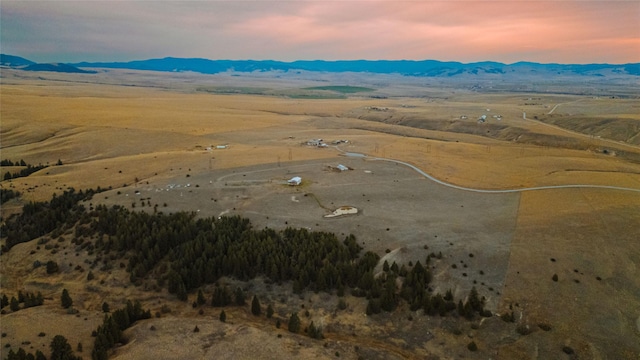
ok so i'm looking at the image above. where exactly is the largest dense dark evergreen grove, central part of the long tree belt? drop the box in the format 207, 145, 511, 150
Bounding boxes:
83, 206, 379, 300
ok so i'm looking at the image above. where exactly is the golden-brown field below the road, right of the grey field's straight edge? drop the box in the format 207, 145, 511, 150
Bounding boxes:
503, 189, 640, 359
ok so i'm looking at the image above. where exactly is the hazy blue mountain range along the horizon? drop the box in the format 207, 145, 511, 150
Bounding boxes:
0, 54, 640, 77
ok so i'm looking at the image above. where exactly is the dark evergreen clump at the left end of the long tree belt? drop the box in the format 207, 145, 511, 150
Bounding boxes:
0, 188, 102, 252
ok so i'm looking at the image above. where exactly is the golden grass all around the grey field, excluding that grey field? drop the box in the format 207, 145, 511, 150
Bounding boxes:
0, 70, 640, 359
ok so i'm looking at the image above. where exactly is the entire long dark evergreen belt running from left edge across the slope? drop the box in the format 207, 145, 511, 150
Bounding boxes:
1, 189, 488, 317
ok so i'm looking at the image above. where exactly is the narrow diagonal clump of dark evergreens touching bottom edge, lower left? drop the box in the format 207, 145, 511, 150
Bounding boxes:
91, 300, 151, 360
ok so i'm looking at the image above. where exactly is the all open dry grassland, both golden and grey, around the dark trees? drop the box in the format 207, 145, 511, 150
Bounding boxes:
0, 71, 640, 359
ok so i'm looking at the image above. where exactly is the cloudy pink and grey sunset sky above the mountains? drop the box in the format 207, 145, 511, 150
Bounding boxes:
0, 0, 640, 64
